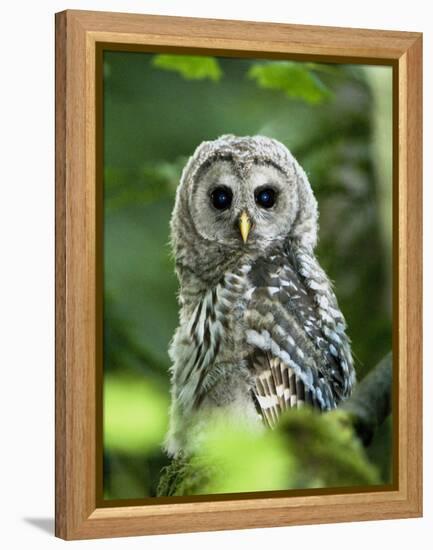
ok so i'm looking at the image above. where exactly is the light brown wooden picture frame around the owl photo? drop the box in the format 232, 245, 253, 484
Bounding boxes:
55, 10, 422, 539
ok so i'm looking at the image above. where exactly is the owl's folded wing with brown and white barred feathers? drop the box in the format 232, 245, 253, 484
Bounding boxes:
245, 245, 354, 426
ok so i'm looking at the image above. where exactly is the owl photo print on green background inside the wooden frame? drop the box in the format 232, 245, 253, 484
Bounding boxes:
101, 50, 395, 504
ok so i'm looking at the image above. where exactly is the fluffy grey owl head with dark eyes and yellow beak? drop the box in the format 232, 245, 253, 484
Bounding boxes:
171, 135, 317, 284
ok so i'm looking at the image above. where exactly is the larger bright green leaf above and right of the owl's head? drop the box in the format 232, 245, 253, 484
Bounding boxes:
248, 61, 332, 105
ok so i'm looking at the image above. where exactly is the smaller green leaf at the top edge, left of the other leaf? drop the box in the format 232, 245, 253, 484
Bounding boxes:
152, 54, 222, 82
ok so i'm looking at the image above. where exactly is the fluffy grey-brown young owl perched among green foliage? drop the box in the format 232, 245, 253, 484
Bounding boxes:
166, 135, 355, 456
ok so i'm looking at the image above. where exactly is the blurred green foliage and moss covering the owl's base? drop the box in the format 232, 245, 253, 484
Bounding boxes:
158, 407, 381, 496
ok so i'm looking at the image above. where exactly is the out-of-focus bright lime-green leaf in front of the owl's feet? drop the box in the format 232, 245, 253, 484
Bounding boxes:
158, 412, 296, 496
